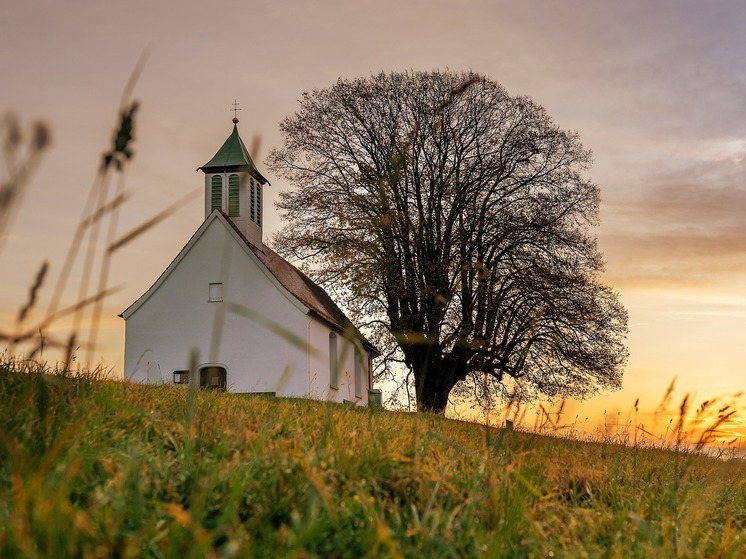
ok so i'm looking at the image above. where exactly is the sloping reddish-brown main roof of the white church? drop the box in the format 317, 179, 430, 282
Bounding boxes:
216, 210, 379, 354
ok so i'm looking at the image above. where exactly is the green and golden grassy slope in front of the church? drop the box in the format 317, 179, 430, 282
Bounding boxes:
0, 366, 746, 558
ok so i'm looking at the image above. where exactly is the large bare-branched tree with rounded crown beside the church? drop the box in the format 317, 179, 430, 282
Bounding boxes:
268, 71, 627, 413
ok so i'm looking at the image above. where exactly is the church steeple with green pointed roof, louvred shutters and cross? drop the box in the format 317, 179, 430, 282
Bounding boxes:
197, 112, 269, 247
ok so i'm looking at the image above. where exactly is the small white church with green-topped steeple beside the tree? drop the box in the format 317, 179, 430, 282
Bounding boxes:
119, 118, 380, 405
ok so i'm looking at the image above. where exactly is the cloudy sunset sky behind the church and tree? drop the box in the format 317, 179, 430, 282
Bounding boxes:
0, 0, 746, 446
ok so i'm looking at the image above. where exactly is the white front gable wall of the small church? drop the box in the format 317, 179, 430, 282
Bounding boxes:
125, 215, 306, 397
